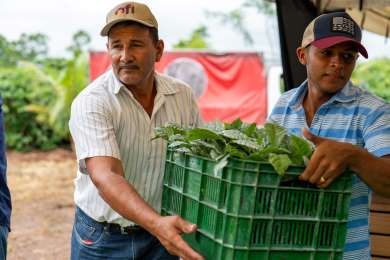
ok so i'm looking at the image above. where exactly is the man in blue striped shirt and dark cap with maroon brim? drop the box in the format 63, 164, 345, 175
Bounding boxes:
269, 12, 390, 259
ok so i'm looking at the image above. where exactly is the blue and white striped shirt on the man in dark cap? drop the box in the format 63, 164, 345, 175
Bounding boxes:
268, 81, 390, 260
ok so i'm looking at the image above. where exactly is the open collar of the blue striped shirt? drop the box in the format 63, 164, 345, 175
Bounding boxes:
289, 80, 357, 108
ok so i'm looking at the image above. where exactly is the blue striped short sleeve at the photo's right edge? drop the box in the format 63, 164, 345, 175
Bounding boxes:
363, 105, 390, 157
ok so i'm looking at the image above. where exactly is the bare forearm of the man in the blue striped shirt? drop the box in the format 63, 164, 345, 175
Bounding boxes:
350, 148, 390, 197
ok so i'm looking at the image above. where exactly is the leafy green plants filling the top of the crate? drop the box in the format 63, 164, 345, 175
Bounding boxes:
155, 119, 314, 175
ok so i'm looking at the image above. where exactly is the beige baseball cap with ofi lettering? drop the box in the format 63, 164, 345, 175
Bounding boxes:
100, 2, 158, 36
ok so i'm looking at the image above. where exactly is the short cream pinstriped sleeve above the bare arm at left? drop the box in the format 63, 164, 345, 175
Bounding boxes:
69, 94, 120, 161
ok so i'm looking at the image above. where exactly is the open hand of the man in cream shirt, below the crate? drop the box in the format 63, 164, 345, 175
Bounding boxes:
151, 216, 204, 260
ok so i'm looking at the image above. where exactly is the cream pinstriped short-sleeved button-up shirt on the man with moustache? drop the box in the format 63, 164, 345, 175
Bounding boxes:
69, 70, 201, 226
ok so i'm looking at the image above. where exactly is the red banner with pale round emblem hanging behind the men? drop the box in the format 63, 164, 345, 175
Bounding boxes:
90, 51, 267, 124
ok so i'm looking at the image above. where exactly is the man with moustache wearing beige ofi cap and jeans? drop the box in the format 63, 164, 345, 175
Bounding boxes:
69, 2, 203, 260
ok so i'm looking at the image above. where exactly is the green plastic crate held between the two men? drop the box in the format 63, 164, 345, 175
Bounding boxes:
162, 150, 352, 260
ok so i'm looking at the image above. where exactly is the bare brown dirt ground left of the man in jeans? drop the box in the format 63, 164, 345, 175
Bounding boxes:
7, 149, 76, 260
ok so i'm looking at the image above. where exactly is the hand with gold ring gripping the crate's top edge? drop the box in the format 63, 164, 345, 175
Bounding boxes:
299, 128, 358, 188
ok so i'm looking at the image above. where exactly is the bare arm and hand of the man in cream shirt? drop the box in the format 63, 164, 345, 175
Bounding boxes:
86, 156, 203, 260
